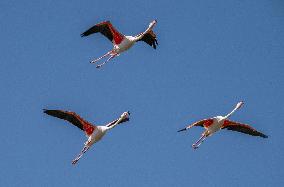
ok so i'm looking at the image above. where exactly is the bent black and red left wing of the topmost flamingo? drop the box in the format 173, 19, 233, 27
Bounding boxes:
81, 21, 123, 42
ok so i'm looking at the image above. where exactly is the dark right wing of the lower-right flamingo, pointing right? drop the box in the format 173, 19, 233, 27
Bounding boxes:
222, 120, 268, 138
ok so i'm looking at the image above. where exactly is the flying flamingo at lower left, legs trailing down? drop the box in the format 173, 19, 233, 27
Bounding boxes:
43, 109, 130, 164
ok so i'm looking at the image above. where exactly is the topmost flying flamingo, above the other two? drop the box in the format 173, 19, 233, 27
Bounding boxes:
81, 20, 158, 68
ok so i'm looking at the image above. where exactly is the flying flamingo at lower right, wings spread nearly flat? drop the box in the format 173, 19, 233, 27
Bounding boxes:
178, 102, 268, 149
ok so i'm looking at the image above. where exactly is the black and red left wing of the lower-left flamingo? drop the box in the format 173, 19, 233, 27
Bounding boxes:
43, 109, 96, 135
